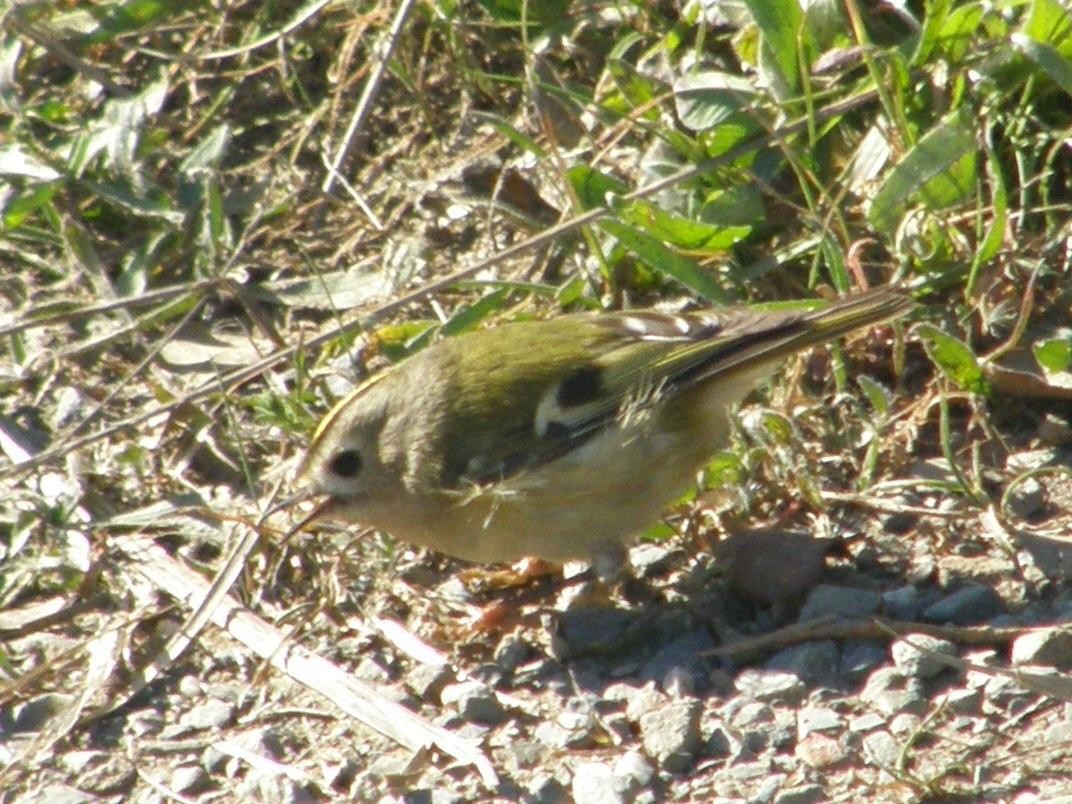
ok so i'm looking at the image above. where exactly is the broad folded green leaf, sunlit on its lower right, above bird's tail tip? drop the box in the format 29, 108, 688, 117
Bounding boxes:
867, 114, 976, 233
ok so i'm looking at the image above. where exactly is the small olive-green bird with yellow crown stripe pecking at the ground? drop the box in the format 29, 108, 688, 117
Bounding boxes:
299, 288, 912, 577
